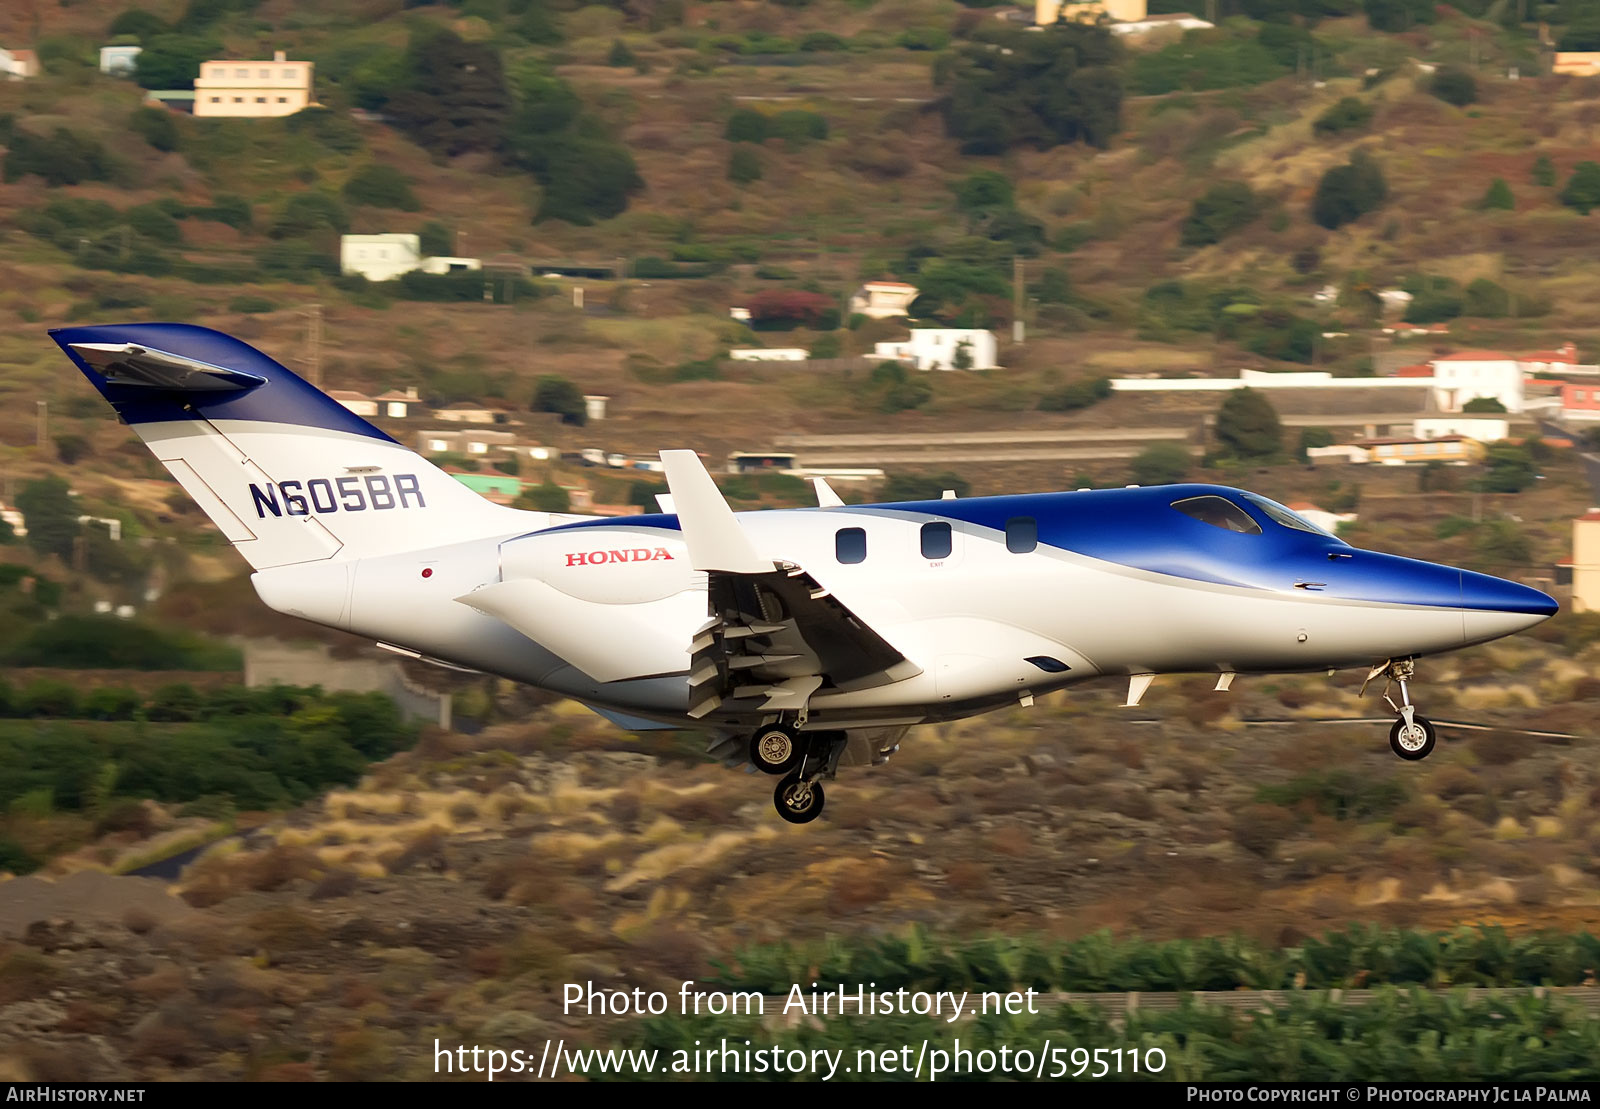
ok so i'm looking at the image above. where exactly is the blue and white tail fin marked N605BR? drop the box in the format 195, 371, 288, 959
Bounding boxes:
50, 323, 521, 570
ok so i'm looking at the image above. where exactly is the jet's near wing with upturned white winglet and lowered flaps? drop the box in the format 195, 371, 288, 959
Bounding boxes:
661, 451, 922, 717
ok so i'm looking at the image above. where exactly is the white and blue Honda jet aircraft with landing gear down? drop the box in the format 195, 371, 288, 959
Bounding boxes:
51, 323, 1557, 824
